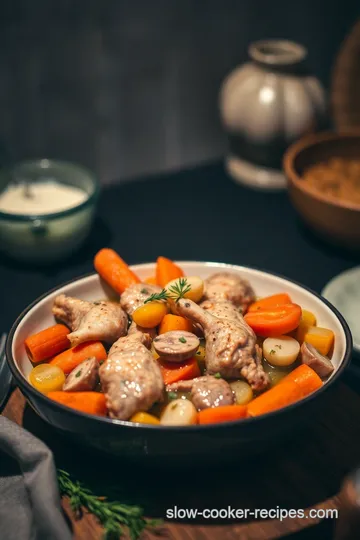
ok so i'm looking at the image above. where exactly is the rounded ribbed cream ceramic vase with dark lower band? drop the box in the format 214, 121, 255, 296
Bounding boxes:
220, 40, 325, 189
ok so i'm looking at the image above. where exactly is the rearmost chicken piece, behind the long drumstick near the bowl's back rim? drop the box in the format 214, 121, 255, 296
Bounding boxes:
204, 272, 255, 313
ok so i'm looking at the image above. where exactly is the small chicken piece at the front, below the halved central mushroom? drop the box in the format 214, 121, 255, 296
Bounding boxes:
166, 375, 235, 411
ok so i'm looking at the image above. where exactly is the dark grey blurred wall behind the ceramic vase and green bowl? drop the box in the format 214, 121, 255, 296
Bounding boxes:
0, 0, 360, 182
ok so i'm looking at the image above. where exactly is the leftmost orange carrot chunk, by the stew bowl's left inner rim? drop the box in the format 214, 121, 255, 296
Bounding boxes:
25, 324, 70, 364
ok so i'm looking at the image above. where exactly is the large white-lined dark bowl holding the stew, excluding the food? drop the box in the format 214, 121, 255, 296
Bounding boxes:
6, 261, 352, 457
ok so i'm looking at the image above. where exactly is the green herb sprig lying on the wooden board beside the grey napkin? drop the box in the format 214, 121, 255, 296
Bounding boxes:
57, 469, 161, 540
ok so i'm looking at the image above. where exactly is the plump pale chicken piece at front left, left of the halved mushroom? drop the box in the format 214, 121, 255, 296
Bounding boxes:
100, 324, 164, 420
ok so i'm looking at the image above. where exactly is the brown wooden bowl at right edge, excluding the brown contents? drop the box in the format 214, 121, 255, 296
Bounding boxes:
283, 129, 360, 250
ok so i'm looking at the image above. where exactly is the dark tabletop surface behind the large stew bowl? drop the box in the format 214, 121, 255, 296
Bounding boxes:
0, 158, 360, 331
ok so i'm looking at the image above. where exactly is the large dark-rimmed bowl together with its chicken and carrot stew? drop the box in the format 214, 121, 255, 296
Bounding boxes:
6, 249, 352, 463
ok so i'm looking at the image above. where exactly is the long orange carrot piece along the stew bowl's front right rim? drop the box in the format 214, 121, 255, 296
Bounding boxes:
247, 377, 304, 416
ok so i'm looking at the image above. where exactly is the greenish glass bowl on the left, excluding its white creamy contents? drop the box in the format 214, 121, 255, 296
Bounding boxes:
0, 159, 100, 264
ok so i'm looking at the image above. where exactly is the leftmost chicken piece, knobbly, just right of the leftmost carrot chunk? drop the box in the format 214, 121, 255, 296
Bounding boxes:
52, 294, 128, 347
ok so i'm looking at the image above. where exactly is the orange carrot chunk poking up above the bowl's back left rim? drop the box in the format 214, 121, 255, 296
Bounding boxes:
94, 248, 140, 294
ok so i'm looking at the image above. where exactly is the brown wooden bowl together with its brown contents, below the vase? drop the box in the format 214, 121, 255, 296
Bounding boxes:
284, 130, 360, 250
